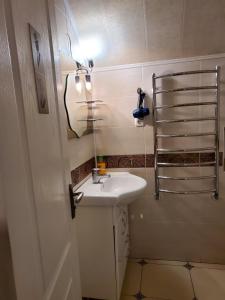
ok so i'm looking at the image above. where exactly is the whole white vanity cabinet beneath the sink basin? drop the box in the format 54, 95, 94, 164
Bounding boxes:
76, 206, 129, 300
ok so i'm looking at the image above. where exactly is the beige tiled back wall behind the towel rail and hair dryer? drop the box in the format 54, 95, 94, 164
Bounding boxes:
93, 55, 225, 263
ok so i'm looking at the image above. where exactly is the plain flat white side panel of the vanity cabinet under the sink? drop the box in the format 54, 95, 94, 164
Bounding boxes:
77, 206, 117, 300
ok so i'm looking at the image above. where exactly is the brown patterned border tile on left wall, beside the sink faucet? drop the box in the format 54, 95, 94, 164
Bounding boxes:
71, 157, 95, 185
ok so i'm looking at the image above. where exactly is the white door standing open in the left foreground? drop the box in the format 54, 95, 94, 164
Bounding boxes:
0, 0, 80, 300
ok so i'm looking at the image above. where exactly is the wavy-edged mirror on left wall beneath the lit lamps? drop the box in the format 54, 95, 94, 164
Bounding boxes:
64, 72, 93, 138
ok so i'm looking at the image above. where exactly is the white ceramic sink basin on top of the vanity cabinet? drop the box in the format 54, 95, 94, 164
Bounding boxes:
76, 172, 147, 206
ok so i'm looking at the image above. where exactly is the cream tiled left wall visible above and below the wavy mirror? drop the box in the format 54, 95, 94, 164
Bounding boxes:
55, 0, 94, 170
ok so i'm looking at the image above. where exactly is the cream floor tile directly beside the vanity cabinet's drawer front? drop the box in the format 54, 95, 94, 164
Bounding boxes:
122, 261, 142, 296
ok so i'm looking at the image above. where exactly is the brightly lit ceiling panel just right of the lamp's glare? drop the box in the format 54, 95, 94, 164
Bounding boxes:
101, 0, 148, 65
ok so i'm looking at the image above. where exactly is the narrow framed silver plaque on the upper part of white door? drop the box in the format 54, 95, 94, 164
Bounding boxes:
29, 24, 49, 114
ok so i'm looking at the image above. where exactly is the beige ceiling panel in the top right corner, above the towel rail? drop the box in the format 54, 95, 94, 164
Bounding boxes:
182, 0, 225, 56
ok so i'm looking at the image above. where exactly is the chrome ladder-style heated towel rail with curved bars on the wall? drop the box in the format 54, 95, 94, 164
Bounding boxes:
152, 66, 220, 200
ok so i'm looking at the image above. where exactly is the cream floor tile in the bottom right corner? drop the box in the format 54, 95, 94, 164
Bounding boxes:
191, 268, 225, 300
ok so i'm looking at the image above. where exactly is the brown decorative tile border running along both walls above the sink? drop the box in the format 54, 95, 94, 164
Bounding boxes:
71, 152, 223, 185
